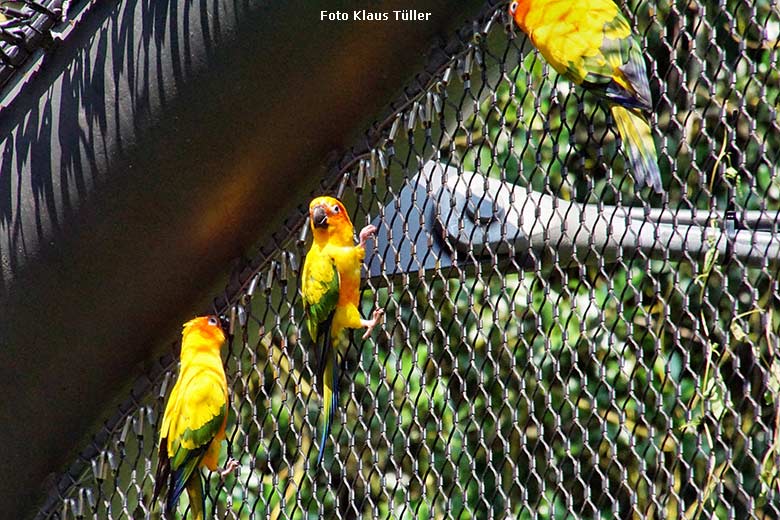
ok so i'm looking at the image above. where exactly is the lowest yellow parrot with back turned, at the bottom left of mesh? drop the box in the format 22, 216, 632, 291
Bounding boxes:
152, 316, 238, 520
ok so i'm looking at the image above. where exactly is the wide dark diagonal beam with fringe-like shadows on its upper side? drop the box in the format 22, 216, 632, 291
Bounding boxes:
0, 0, 481, 518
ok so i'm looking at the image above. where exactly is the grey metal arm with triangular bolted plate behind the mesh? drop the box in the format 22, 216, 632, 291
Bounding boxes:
368, 161, 780, 279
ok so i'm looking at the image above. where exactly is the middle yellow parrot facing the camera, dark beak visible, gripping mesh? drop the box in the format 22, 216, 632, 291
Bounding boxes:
301, 197, 384, 464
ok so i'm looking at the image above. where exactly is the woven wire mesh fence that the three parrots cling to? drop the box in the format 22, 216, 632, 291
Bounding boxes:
39, 0, 780, 519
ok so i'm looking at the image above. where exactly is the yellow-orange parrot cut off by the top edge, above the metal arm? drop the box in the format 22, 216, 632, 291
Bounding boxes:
509, 0, 663, 193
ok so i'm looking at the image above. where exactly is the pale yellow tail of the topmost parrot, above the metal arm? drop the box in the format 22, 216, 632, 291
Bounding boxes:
611, 105, 664, 193
